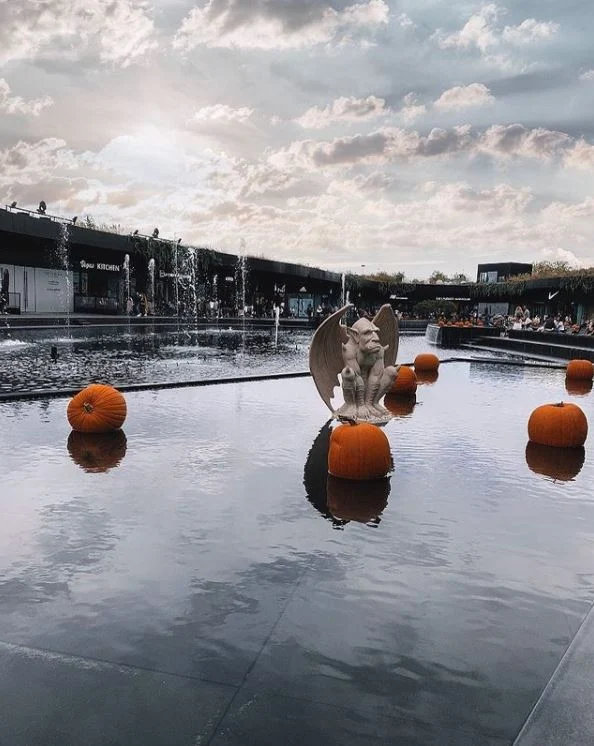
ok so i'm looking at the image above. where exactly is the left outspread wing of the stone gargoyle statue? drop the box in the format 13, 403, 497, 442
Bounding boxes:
309, 303, 351, 412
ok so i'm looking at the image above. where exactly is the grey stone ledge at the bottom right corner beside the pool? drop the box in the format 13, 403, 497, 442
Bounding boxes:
514, 609, 594, 746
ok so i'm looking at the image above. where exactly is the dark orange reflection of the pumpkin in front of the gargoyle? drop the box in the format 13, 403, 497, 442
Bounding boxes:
327, 474, 390, 523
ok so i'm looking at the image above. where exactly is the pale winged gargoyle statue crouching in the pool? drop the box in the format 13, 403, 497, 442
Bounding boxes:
309, 304, 400, 423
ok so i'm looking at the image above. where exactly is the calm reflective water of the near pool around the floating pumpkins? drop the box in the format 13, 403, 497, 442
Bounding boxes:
0, 358, 594, 746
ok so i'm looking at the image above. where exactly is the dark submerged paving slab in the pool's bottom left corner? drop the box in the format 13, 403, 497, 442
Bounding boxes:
0, 643, 236, 746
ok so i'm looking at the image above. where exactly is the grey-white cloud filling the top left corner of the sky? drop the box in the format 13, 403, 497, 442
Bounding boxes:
0, 0, 156, 67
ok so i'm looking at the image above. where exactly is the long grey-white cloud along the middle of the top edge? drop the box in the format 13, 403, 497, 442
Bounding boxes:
173, 0, 389, 51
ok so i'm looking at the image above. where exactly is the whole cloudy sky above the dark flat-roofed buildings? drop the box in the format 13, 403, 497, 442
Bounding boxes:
0, 0, 594, 278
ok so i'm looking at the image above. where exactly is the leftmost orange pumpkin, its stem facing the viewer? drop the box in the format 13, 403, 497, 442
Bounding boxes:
66, 383, 126, 433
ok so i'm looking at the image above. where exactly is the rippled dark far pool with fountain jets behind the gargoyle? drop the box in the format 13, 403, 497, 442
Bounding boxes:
0, 328, 484, 392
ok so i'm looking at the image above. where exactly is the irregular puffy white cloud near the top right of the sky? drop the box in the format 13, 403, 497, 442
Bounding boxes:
433, 3, 559, 67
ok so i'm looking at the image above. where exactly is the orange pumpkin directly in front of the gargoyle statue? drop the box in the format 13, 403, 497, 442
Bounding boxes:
328, 422, 392, 480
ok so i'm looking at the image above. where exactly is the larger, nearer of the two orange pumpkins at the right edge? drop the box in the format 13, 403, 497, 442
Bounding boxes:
528, 402, 588, 448
